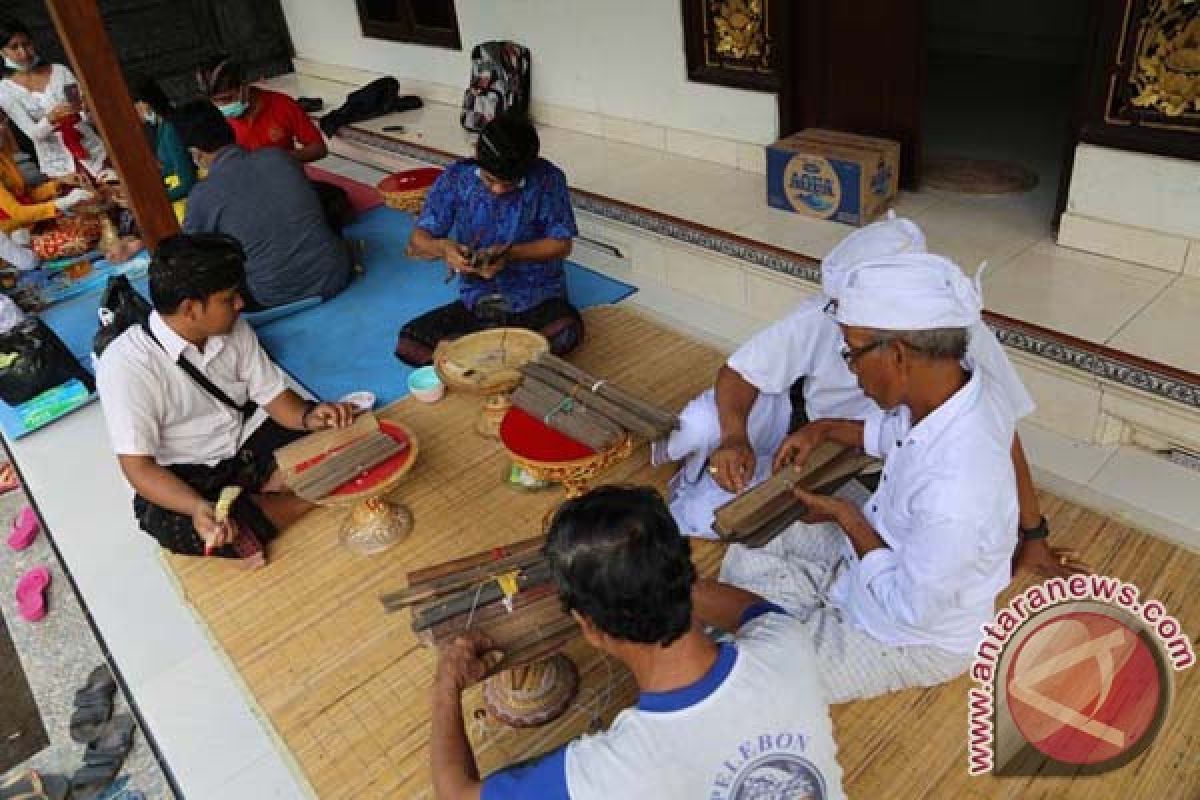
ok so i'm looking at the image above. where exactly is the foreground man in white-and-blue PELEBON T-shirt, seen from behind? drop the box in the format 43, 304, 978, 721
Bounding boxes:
430, 487, 846, 800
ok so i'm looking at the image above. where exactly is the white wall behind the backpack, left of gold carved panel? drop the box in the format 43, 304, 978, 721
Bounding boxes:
282, 0, 779, 144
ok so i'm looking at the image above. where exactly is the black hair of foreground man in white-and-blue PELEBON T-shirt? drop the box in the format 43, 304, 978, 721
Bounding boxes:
545, 486, 696, 646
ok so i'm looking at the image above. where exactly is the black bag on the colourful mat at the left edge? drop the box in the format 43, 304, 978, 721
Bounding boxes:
0, 317, 96, 405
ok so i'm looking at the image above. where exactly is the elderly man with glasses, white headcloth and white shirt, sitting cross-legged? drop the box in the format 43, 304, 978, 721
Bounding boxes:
721, 253, 1018, 703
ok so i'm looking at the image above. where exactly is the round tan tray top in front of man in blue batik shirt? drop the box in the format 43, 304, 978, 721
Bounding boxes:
433, 327, 550, 395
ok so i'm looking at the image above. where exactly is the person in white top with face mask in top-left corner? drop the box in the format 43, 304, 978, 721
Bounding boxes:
0, 22, 108, 179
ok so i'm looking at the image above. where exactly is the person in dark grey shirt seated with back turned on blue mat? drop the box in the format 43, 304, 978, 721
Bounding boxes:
172, 100, 352, 309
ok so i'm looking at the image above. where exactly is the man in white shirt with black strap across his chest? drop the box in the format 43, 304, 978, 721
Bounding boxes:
96, 234, 354, 566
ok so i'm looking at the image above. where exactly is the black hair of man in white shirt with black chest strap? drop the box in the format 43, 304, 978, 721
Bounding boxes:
150, 234, 246, 314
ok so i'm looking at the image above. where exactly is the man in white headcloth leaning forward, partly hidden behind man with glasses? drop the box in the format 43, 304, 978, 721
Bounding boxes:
654, 212, 1084, 576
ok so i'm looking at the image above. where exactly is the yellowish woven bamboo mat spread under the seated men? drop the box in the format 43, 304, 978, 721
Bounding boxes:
168, 307, 1200, 800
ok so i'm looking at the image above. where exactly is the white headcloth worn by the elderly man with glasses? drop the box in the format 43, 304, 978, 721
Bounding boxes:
838, 253, 983, 331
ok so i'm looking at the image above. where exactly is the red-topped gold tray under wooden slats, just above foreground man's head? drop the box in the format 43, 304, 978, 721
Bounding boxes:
499, 408, 634, 498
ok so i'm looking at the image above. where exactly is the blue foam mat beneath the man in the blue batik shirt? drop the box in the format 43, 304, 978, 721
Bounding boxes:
258, 207, 636, 405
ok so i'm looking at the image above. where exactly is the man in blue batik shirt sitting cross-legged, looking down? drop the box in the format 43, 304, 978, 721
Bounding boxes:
396, 115, 583, 366
